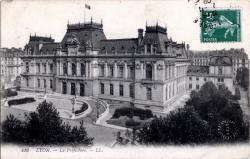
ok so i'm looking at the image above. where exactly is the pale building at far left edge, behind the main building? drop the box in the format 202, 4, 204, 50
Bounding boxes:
0, 48, 23, 87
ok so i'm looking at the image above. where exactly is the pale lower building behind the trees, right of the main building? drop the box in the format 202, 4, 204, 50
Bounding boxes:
187, 56, 235, 94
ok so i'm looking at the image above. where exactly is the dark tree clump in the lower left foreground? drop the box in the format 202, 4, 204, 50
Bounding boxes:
3, 101, 93, 145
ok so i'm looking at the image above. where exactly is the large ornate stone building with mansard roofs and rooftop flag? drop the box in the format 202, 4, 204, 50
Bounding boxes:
22, 20, 189, 108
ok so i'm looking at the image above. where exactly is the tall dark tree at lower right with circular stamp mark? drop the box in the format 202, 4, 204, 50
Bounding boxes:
186, 82, 247, 142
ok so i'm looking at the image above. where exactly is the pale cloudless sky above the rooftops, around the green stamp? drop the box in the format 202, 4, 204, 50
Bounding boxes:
1, 0, 250, 55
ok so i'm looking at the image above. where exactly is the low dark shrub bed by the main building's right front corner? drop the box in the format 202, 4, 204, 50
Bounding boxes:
113, 107, 153, 120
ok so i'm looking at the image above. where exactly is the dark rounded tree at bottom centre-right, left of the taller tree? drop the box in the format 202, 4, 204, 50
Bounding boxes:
136, 107, 208, 145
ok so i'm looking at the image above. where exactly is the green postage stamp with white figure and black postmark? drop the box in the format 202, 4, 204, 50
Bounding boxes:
200, 9, 241, 42
